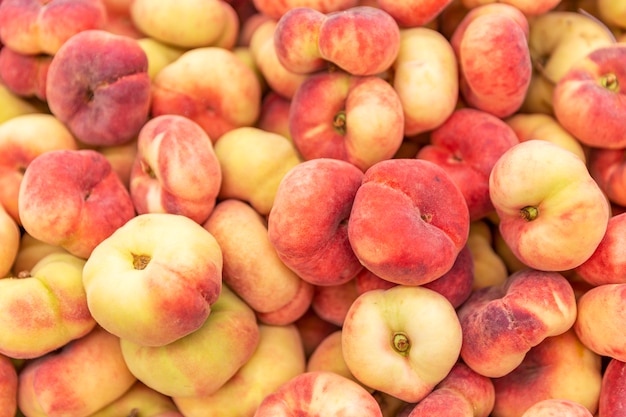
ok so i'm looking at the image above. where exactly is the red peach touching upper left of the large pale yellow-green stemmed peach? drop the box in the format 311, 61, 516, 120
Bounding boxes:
18, 149, 135, 258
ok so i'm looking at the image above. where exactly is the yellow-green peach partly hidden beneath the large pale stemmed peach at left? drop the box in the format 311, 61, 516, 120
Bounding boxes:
120, 286, 260, 397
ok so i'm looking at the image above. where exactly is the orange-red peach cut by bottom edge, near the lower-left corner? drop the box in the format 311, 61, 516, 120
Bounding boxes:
17, 327, 136, 417
